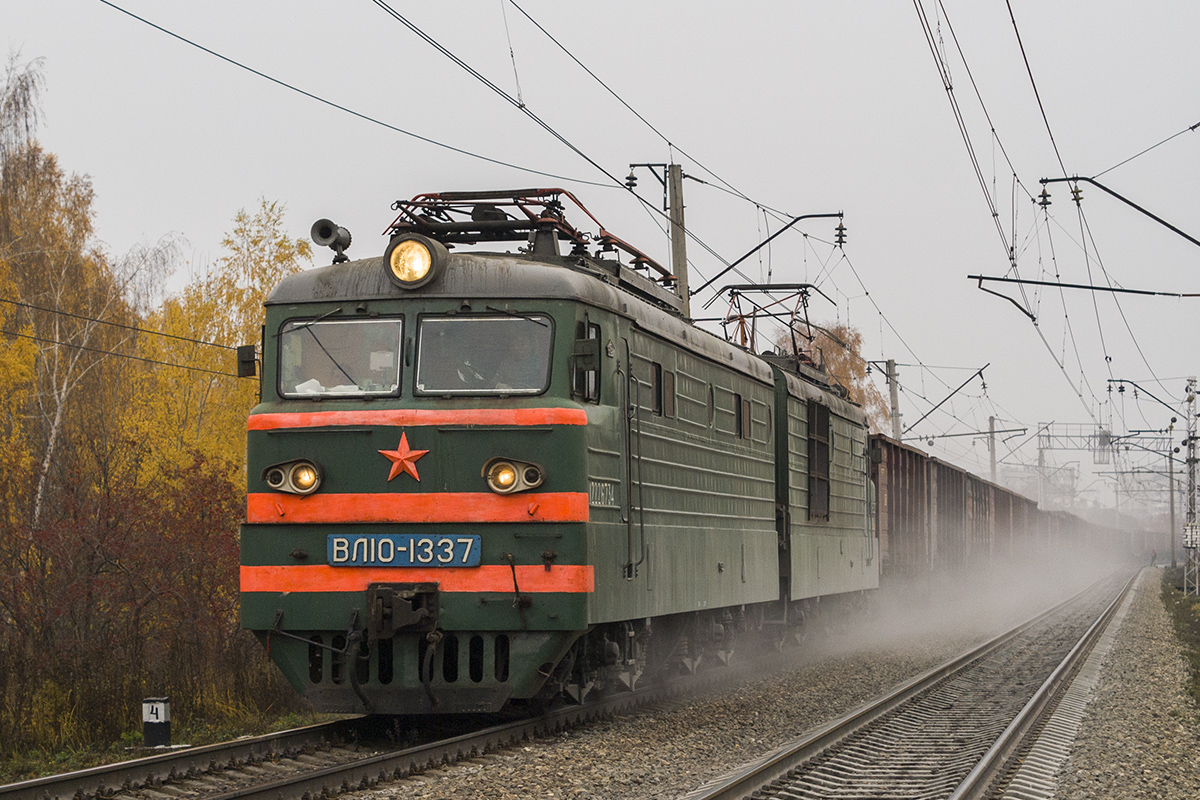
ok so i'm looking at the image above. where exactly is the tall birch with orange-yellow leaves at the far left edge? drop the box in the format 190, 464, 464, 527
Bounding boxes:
0, 62, 172, 528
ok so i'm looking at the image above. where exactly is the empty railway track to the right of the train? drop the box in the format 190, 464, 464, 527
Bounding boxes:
686, 568, 1134, 800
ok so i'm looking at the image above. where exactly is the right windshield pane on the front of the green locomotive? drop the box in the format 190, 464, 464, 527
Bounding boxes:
416, 314, 554, 395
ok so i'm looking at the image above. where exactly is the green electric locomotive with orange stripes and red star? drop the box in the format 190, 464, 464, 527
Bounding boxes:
241, 190, 878, 714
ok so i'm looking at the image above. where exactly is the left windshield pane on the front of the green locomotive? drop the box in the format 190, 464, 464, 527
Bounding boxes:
280, 319, 404, 398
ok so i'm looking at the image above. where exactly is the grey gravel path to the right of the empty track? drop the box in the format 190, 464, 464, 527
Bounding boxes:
1055, 569, 1200, 800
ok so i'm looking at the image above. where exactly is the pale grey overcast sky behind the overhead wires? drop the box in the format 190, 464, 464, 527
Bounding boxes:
0, 0, 1200, 515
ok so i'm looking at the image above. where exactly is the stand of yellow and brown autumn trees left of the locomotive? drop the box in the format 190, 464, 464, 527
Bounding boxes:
0, 57, 308, 757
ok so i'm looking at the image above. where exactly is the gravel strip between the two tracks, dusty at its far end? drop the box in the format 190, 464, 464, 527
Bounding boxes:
346, 563, 1108, 800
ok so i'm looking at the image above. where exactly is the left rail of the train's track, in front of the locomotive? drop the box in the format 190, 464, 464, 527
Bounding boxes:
0, 717, 365, 800
